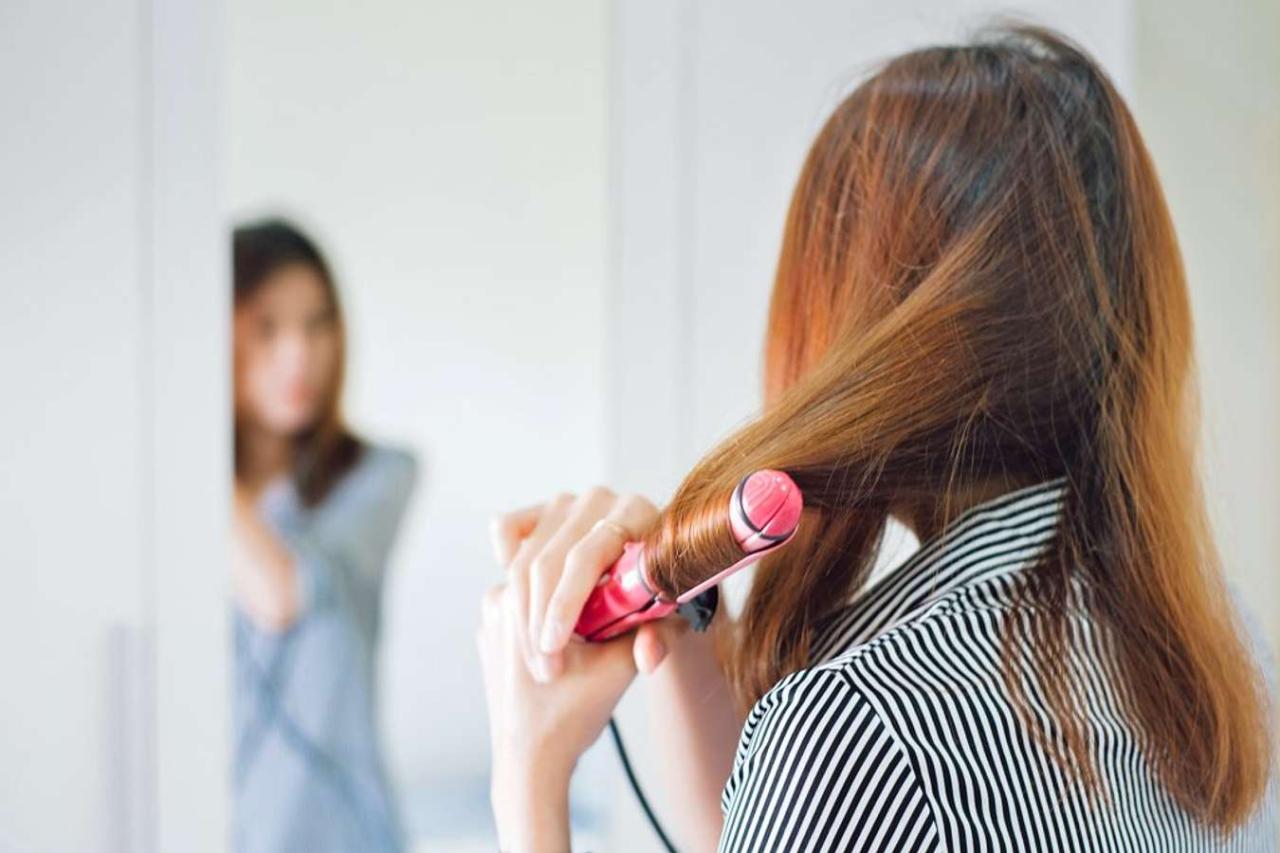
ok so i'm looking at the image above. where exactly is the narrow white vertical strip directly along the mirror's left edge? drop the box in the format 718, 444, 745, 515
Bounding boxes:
142, 0, 230, 850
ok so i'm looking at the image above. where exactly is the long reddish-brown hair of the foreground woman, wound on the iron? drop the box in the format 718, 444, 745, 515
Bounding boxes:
646, 27, 1270, 829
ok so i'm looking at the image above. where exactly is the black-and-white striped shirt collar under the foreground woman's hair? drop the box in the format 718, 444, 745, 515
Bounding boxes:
810, 478, 1066, 662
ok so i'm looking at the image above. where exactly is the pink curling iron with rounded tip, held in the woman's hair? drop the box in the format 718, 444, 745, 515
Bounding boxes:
573, 470, 804, 643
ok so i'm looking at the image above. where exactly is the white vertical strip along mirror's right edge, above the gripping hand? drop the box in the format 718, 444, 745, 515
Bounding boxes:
607, 0, 694, 501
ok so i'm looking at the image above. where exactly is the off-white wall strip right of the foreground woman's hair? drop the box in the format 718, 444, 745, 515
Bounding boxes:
1133, 0, 1280, 646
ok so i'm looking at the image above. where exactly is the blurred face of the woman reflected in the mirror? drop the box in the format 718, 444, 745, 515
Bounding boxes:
234, 264, 340, 435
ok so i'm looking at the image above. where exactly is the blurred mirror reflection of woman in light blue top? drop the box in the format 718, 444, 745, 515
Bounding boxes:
232, 222, 415, 850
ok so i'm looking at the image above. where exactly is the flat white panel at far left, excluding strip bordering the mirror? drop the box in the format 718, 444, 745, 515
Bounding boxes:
0, 3, 145, 850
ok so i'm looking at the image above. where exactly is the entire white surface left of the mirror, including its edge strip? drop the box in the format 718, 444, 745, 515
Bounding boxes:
0, 0, 229, 850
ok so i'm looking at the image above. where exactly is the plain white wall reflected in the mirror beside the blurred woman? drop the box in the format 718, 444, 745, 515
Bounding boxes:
228, 0, 608, 830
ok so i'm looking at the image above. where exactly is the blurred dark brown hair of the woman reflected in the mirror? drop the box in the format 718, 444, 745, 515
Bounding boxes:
232, 219, 361, 506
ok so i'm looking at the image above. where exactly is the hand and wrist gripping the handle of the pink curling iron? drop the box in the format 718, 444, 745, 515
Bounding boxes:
477, 489, 684, 850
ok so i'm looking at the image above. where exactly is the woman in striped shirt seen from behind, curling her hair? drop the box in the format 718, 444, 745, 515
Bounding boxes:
480, 28, 1276, 850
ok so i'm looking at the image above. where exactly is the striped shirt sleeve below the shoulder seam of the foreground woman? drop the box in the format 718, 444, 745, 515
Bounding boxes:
721, 666, 937, 850
